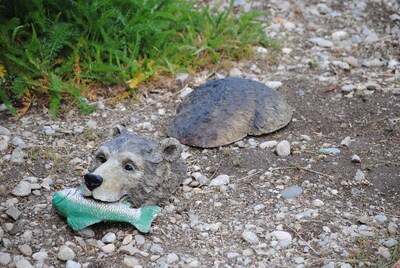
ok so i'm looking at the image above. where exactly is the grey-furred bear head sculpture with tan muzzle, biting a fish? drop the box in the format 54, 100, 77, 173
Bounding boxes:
83, 126, 186, 207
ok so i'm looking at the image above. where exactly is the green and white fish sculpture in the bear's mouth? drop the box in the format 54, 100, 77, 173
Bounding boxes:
52, 188, 161, 233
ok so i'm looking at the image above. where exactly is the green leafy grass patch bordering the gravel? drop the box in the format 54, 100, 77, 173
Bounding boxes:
0, 0, 273, 115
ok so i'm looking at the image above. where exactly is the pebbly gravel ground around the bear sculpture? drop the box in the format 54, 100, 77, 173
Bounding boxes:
0, 0, 400, 268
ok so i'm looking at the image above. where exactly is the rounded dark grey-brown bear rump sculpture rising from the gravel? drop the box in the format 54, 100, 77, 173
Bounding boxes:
167, 77, 293, 148
